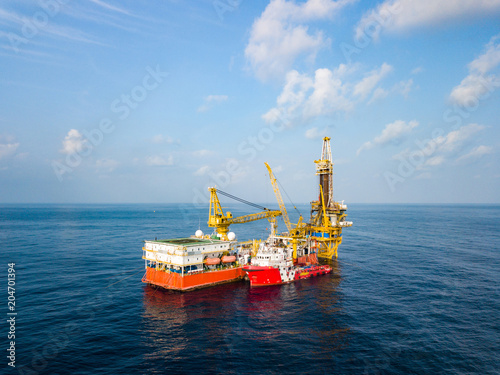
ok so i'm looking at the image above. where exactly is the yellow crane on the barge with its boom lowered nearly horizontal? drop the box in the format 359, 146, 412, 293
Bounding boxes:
208, 187, 282, 241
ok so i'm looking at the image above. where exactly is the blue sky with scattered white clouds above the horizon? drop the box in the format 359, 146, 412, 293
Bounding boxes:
0, 0, 500, 205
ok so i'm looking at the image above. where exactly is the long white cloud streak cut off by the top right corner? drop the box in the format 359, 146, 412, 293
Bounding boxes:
355, 0, 500, 40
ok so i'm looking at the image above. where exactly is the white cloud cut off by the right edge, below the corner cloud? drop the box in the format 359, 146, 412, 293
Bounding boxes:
450, 35, 500, 107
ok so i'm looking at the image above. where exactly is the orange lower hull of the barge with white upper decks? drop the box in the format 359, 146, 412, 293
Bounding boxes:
142, 267, 245, 292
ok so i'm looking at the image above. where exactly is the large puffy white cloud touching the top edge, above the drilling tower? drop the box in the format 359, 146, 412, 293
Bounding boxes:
245, 0, 355, 80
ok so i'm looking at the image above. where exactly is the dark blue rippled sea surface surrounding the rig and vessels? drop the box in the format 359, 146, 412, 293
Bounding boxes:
0, 204, 500, 374
